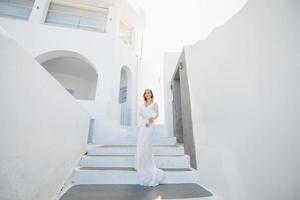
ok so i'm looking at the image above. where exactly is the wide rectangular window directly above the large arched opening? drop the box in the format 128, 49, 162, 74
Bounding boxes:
45, 2, 108, 32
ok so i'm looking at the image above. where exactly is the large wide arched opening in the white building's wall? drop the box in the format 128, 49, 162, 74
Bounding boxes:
36, 51, 98, 100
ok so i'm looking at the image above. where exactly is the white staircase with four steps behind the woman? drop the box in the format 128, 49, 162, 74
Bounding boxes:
72, 137, 198, 184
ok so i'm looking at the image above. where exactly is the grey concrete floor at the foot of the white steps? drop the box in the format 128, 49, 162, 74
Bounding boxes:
58, 183, 221, 200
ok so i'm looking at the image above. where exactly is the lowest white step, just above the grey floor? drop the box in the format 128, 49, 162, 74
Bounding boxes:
72, 167, 198, 184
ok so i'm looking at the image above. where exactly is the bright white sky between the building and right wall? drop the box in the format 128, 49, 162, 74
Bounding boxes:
128, 0, 247, 123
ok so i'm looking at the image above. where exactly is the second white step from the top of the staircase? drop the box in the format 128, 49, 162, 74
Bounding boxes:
87, 145, 184, 156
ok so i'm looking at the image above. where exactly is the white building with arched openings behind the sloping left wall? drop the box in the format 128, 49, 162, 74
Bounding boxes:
0, 0, 144, 143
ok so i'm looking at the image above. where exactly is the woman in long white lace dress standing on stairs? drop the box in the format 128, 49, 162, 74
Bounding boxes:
134, 89, 165, 186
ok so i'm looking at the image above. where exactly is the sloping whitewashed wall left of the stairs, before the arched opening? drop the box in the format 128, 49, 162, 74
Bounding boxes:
0, 27, 90, 200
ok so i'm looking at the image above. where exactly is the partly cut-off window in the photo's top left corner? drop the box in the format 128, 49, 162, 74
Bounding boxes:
0, 0, 34, 20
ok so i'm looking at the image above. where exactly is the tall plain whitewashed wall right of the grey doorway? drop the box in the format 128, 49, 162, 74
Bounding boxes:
165, 0, 300, 200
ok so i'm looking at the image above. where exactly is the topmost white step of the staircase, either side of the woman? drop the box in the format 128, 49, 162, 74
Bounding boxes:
107, 137, 177, 145
